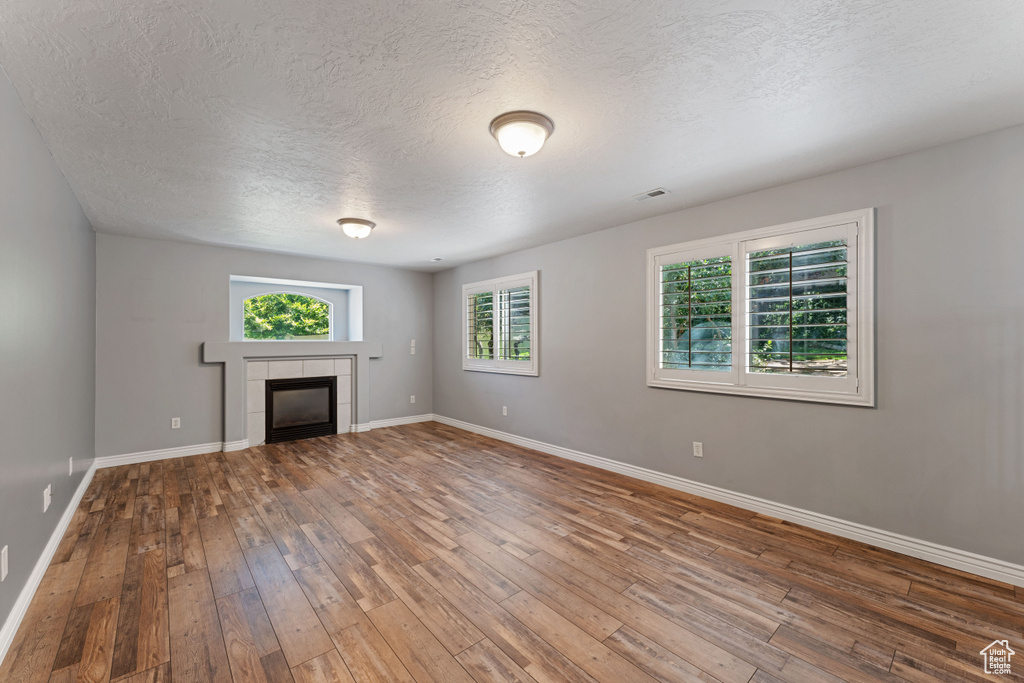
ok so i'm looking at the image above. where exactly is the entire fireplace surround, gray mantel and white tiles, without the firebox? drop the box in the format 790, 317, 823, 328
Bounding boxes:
201, 341, 383, 451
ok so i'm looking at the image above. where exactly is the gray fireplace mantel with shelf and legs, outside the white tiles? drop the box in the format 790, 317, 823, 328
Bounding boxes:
200, 341, 384, 451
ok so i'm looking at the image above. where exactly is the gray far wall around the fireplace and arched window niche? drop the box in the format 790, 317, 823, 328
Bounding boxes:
96, 234, 433, 456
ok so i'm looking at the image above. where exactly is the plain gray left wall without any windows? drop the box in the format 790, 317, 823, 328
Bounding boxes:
0, 71, 96, 625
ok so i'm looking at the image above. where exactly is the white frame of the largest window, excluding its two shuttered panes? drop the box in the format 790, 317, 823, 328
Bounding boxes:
647, 209, 874, 407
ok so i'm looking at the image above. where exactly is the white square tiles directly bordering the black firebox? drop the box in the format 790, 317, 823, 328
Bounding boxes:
246, 358, 352, 446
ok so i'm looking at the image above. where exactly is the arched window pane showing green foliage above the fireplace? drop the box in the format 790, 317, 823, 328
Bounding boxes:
245, 293, 331, 339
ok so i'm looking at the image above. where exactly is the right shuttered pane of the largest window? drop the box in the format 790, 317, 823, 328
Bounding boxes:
746, 240, 848, 377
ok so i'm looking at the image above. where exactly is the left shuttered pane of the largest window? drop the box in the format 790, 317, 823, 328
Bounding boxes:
659, 256, 732, 372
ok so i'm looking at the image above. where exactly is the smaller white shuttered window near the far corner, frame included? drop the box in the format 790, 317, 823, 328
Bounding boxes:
462, 270, 538, 375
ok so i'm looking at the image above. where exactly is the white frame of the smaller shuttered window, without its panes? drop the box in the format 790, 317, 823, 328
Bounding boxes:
460, 270, 541, 376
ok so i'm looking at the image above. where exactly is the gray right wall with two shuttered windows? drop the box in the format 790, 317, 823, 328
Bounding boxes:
434, 122, 1024, 563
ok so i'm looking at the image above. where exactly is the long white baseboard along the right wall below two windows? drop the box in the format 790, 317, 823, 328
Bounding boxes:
434, 415, 1024, 587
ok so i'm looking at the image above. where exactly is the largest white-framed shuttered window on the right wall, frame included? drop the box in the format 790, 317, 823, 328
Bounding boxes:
647, 209, 874, 405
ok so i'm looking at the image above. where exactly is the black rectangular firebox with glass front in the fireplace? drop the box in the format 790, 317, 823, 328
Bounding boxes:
266, 377, 338, 443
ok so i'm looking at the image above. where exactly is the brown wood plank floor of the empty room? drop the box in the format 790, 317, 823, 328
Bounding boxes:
0, 423, 1024, 683
